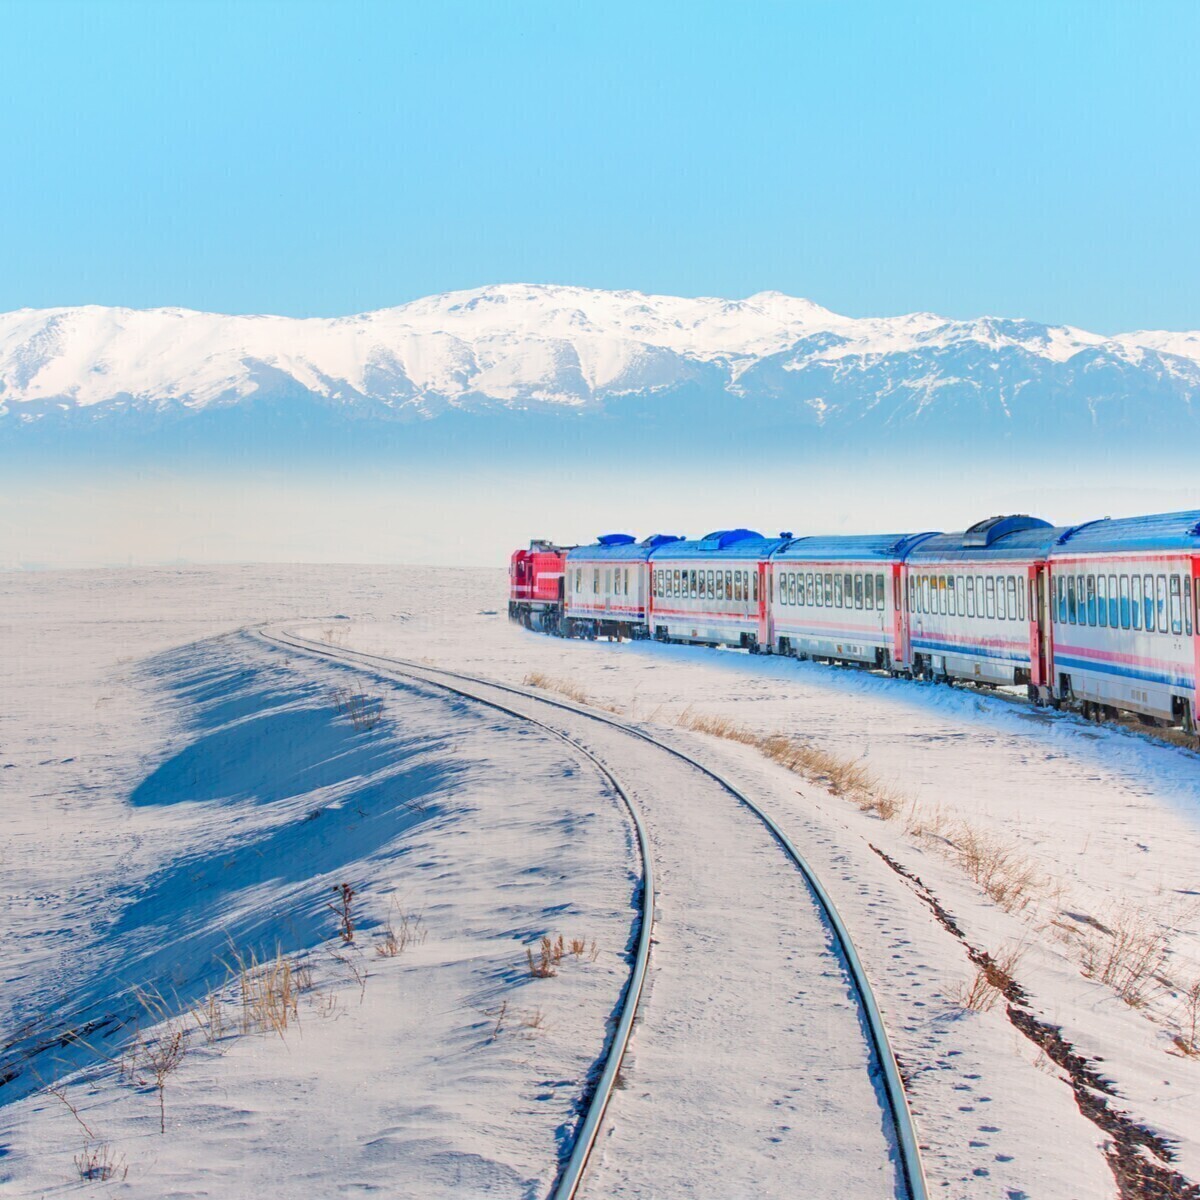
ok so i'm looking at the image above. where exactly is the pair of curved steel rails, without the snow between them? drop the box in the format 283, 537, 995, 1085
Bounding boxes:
258, 628, 928, 1200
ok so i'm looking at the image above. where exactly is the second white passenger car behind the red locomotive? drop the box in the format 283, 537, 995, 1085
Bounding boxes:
649, 529, 791, 652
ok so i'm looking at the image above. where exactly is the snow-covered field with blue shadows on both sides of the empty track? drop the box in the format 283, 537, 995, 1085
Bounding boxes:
0, 566, 1200, 1200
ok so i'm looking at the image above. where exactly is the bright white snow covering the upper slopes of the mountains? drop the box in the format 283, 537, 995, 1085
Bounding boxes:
0, 284, 1200, 408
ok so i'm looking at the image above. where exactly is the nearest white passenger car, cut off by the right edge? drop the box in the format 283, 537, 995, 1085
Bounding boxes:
1050, 511, 1200, 732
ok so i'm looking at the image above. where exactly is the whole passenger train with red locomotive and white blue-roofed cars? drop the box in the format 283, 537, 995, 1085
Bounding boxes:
509, 511, 1200, 739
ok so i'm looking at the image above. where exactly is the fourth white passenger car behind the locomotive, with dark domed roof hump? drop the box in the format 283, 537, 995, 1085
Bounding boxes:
904, 516, 1066, 698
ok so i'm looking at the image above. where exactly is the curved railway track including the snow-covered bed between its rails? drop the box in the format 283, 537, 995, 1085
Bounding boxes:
262, 629, 926, 1200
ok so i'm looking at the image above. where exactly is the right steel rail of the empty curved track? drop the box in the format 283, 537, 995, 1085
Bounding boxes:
267, 635, 929, 1200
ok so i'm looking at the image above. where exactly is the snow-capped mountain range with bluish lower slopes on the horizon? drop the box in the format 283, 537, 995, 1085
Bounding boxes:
0, 284, 1200, 439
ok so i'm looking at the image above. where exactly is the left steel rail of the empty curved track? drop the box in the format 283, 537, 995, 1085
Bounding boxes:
250, 629, 656, 1200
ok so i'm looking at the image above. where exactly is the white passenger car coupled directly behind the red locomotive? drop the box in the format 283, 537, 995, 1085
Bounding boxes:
563, 533, 680, 637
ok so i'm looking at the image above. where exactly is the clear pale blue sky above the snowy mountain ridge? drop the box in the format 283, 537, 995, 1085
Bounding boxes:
0, 0, 1200, 332
